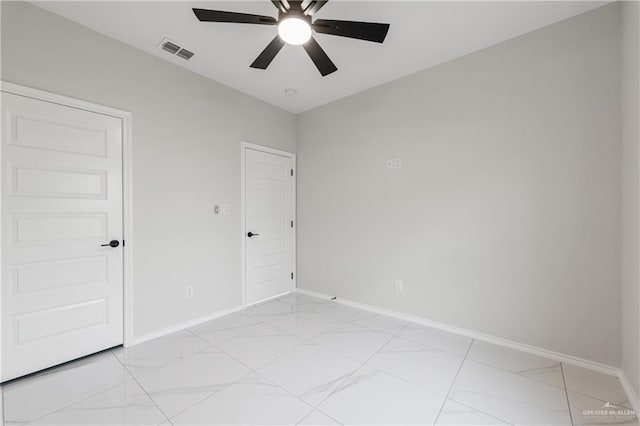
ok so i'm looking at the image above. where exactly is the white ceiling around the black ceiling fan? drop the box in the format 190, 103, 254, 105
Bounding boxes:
34, 0, 604, 113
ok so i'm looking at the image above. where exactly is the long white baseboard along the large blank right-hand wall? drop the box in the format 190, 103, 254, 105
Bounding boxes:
297, 288, 624, 378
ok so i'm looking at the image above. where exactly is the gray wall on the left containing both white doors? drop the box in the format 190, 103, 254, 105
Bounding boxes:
2, 2, 295, 336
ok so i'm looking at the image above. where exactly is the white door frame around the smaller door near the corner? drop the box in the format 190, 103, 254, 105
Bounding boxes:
240, 141, 298, 307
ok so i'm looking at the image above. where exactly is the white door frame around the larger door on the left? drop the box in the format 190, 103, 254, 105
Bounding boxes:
0, 80, 134, 380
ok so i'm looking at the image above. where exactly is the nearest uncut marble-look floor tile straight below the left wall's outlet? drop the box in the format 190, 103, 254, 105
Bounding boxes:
139, 348, 251, 417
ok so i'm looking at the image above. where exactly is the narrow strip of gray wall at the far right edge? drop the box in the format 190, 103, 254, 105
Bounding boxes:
622, 1, 640, 395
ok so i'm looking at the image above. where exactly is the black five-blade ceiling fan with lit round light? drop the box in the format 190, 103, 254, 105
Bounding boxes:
193, 0, 389, 77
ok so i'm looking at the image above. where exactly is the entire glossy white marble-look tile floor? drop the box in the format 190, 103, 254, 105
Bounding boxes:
2, 293, 635, 425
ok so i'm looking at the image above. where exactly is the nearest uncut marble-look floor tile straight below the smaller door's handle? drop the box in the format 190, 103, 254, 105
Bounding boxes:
217, 324, 303, 369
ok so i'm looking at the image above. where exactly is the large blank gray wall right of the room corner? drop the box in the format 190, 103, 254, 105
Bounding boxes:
298, 4, 621, 365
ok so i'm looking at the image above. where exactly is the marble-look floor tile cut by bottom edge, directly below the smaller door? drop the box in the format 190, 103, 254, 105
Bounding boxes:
171, 373, 312, 425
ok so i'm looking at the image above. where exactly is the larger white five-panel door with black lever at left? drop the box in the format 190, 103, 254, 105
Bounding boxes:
0, 92, 123, 381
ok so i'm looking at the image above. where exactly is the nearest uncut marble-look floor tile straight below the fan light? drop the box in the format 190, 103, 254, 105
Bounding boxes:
260, 343, 361, 406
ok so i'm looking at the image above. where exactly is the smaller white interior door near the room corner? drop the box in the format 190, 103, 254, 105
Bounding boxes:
244, 148, 295, 304
